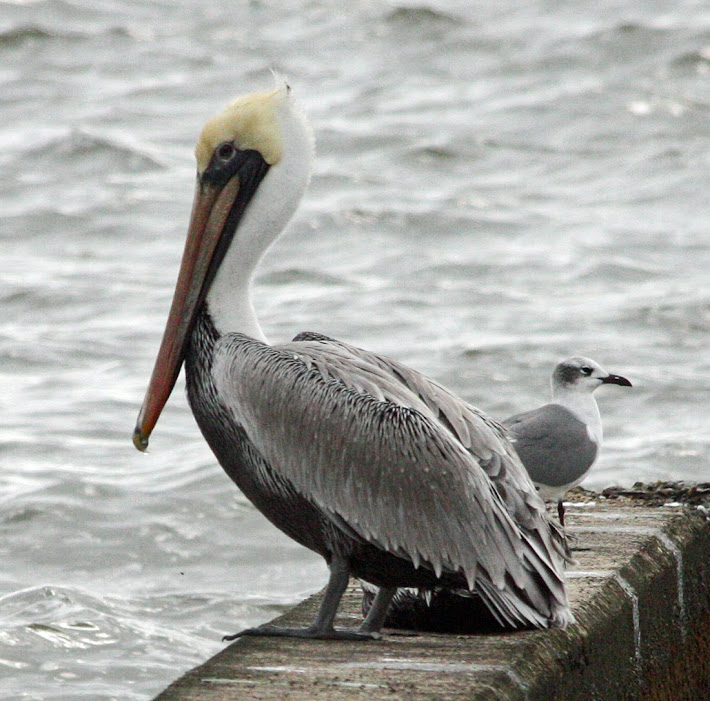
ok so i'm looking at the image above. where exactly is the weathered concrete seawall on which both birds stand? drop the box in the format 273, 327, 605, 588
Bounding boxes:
156, 488, 710, 701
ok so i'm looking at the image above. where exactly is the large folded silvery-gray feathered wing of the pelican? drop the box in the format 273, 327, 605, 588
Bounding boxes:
213, 334, 569, 624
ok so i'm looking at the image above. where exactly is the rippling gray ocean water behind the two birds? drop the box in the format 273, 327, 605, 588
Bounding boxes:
0, 0, 710, 701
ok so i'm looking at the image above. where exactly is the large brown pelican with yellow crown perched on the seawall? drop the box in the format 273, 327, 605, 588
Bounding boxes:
134, 86, 572, 639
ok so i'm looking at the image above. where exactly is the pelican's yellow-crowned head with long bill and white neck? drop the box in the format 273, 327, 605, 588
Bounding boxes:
133, 84, 313, 450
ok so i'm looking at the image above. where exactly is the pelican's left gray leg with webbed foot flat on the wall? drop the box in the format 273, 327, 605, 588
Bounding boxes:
222, 556, 380, 641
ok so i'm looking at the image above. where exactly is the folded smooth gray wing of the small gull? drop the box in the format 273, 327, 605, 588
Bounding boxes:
504, 404, 599, 487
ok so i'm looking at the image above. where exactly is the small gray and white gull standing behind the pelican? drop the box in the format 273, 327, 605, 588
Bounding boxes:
503, 356, 631, 526
